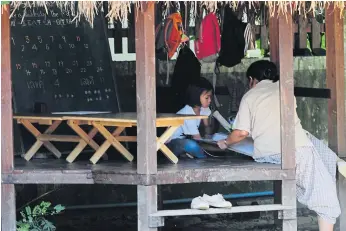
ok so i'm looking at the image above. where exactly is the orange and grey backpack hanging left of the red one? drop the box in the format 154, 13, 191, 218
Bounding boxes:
155, 13, 184, 59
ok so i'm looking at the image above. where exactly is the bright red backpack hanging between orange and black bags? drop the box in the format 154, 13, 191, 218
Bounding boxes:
195, 13, 221, 63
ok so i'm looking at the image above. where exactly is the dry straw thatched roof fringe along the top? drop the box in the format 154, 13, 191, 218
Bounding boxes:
2, 1, 345, 24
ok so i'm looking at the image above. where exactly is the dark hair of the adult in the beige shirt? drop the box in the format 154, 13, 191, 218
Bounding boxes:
246, 60, 280, 83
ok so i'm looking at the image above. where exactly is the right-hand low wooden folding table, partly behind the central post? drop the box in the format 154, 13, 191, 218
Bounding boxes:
63, 112, 207, 164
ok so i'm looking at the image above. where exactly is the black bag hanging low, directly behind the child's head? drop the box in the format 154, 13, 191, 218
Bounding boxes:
172, 45, 201, 111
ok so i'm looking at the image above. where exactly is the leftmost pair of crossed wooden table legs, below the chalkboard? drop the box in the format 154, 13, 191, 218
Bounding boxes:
20, 120, 62, 161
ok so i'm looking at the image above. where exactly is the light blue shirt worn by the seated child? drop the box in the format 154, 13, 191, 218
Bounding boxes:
171, 105, 211, 140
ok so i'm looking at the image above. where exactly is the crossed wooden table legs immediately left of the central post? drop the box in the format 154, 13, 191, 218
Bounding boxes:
90, 122, 133, 164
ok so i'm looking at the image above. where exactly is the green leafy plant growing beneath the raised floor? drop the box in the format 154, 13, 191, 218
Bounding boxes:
17, 201, 65, 231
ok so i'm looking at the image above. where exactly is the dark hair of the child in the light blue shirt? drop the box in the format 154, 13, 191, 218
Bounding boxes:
186, 77, 214, 107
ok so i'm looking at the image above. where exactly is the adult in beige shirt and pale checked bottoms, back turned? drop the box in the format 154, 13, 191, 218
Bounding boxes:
218, 60, 341, 231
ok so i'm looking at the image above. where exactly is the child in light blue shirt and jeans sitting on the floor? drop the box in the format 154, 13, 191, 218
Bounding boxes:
167, 78, 213, 159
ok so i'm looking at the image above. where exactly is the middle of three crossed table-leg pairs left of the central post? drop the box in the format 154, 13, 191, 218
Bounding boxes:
66, 120, 108, 163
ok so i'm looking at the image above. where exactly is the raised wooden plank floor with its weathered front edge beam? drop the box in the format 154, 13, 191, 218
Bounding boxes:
2, 156, 294, 185
